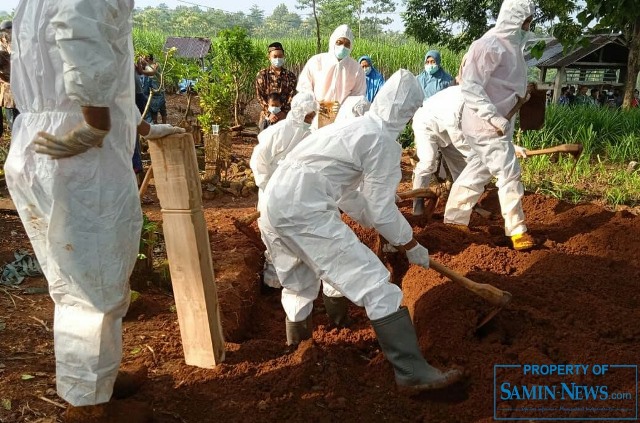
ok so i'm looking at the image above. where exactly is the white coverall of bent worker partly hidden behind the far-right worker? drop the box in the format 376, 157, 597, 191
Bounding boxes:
412, 85, 471, 189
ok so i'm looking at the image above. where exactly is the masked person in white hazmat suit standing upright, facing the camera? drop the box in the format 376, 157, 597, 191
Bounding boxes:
296, 25, 367, 129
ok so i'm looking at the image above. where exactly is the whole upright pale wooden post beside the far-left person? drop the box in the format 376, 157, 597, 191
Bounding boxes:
149, 134, 224, 368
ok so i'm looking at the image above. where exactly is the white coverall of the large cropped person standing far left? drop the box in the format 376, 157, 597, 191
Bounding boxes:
5, 0, 142, 406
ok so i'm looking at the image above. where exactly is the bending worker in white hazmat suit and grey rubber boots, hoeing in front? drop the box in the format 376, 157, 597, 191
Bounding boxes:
260, 69, 461, 390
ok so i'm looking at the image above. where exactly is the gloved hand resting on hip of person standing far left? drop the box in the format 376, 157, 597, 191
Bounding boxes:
34, 122, 109, 159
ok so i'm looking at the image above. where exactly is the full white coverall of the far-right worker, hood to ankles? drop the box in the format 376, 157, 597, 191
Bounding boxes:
444, 0, 534, 236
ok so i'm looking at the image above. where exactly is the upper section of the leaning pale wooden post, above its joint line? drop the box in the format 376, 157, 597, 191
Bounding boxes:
149, 133, 202, 210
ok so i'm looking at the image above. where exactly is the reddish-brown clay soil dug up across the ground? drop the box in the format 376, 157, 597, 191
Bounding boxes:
0, 97, 640, 423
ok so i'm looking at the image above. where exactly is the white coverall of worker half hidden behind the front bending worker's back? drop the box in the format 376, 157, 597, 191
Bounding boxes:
249, 93, 318, 288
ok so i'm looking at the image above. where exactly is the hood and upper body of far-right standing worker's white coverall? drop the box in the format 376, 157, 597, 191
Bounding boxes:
461, 0, 535, 127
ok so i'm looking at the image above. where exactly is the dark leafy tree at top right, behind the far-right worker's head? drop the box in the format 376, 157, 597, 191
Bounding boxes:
403, 0, 640, 108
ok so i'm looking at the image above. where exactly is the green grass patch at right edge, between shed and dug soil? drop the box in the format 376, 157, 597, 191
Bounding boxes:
516, 106, 640, 208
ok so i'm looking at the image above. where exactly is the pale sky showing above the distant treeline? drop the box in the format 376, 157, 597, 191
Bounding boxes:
0, 0, 404, 32
